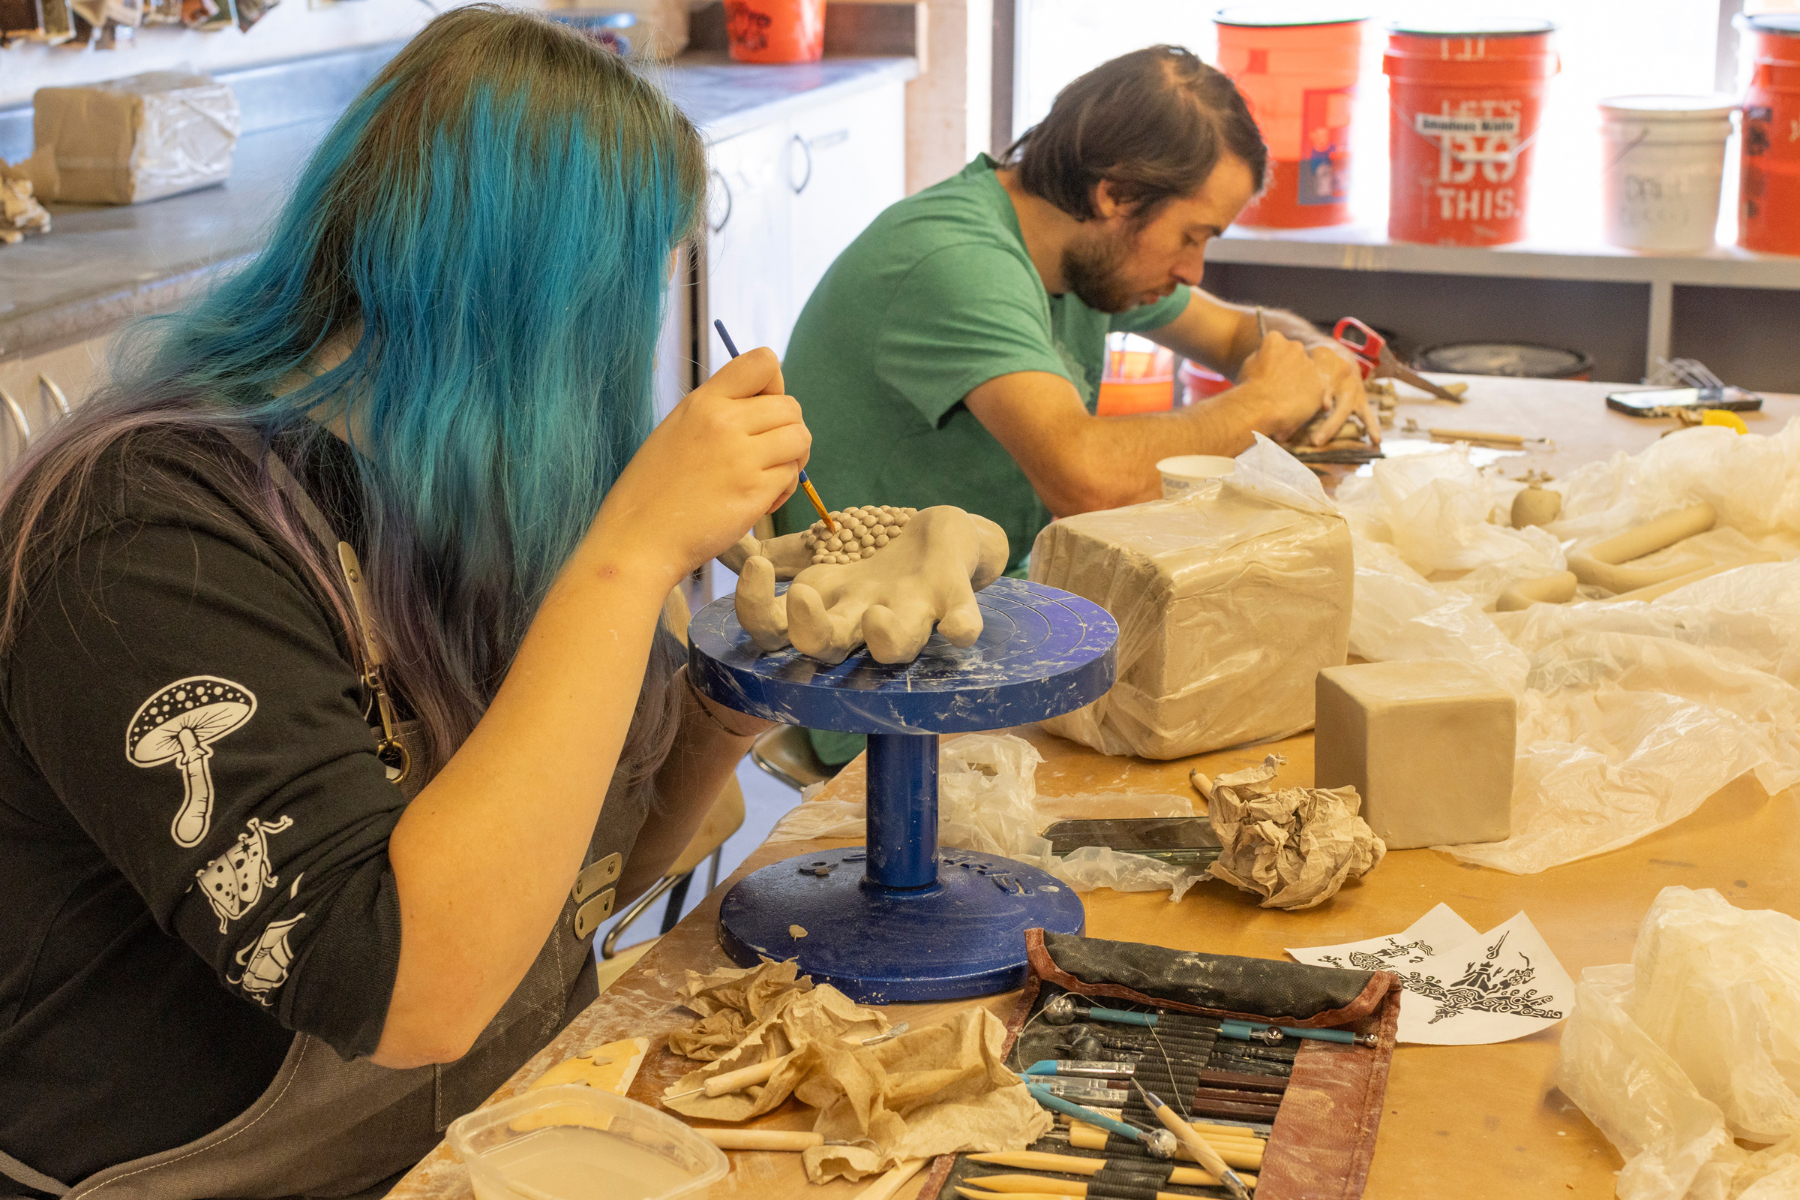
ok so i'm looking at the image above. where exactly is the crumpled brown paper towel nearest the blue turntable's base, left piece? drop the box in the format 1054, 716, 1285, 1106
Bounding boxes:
662, 961, 887, 1121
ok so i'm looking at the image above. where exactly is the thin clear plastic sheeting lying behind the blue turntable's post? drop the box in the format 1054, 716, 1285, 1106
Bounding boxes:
769, 734, 1206, 900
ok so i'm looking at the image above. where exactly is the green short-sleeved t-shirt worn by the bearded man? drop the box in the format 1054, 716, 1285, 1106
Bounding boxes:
776, 155, 1188, 574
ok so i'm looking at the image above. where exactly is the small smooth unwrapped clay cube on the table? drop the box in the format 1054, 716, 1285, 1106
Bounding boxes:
1312, 658, 1517, 849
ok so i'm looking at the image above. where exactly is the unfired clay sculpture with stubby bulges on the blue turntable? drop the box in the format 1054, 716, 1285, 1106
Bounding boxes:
720, 506, 1008, 664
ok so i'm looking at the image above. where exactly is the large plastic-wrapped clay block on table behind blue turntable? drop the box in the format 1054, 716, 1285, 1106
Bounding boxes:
1031, 437, 1354, 759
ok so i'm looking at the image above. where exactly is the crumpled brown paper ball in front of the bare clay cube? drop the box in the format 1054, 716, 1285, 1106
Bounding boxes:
1193, 754, 1388, 910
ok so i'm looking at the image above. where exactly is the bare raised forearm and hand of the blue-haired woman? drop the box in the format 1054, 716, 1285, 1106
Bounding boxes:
373, 349, 812, 1067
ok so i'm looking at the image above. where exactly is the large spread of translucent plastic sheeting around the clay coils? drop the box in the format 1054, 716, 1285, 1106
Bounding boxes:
1337, 423, 1800, 874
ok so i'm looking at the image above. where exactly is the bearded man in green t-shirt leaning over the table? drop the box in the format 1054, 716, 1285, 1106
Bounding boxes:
776, 47, 1379, 763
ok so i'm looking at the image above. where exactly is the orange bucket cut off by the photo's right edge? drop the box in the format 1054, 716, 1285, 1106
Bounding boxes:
1737, 13, 1800, 254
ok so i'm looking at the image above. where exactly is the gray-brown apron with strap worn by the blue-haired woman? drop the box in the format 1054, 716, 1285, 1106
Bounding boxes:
0, 437, 650, 1200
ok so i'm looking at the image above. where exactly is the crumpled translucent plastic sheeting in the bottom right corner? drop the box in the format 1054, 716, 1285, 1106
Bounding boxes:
1557, 887, 1800, 1200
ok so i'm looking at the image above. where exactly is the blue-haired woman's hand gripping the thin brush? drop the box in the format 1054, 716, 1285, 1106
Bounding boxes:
583, 347, 812, 590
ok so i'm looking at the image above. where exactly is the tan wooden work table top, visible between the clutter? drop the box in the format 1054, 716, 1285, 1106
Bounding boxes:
391, 380, 1800, 1200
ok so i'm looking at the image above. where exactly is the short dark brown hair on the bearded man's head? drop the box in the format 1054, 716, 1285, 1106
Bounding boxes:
1006, 45, 1269, 221
